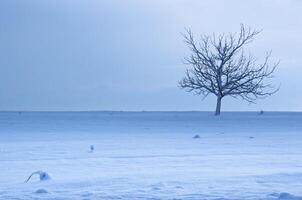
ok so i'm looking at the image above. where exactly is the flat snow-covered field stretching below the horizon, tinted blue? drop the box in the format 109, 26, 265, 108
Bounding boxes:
0, 112, 302, 200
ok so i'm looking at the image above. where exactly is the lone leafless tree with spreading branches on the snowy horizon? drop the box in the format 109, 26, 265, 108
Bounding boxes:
179, 25, 279, 115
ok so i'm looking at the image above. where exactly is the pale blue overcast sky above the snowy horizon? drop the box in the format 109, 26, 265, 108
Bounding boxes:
0, 0, 302, 111
